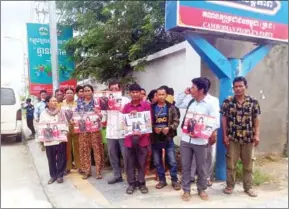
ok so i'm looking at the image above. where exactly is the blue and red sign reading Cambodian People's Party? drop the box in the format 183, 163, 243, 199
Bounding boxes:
166, 0, 288, 42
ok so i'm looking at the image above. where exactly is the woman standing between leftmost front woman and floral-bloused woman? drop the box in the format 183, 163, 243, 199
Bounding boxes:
61, 88, 80, 175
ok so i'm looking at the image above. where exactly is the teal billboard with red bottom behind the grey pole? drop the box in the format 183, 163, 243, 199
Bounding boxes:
27, 23, 76, 95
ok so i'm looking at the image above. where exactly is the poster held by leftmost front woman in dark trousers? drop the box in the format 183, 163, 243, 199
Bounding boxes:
37, 122, 68, 142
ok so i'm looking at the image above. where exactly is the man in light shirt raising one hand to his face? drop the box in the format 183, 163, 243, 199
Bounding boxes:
176, 77, 219, 201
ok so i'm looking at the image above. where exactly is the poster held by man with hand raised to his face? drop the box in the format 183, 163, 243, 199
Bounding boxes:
183, 112, 216, 139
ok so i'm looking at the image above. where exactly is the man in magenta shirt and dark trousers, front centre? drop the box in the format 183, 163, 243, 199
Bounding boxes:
123, 84, 151, 194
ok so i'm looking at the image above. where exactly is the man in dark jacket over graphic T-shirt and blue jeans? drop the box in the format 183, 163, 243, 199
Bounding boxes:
151, 87, 181, 190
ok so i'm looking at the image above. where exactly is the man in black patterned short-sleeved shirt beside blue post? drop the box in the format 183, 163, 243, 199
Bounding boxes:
221, 76, 261, 197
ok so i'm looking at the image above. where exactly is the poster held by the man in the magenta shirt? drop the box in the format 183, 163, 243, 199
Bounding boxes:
122, 111, 152, 136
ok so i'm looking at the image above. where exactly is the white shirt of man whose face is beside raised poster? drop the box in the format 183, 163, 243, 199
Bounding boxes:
106, 96, 130, 139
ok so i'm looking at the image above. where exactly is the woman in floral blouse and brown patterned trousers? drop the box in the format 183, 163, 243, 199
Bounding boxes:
76, 84, 104, 179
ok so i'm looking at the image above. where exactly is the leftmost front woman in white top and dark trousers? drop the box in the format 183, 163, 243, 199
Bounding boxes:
39, 96, 66, 184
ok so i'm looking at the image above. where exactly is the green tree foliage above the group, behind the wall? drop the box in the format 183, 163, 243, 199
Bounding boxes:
57, 1, 183, 83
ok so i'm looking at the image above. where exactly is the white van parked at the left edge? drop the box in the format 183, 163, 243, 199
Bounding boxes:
1, 86, 22, 142
